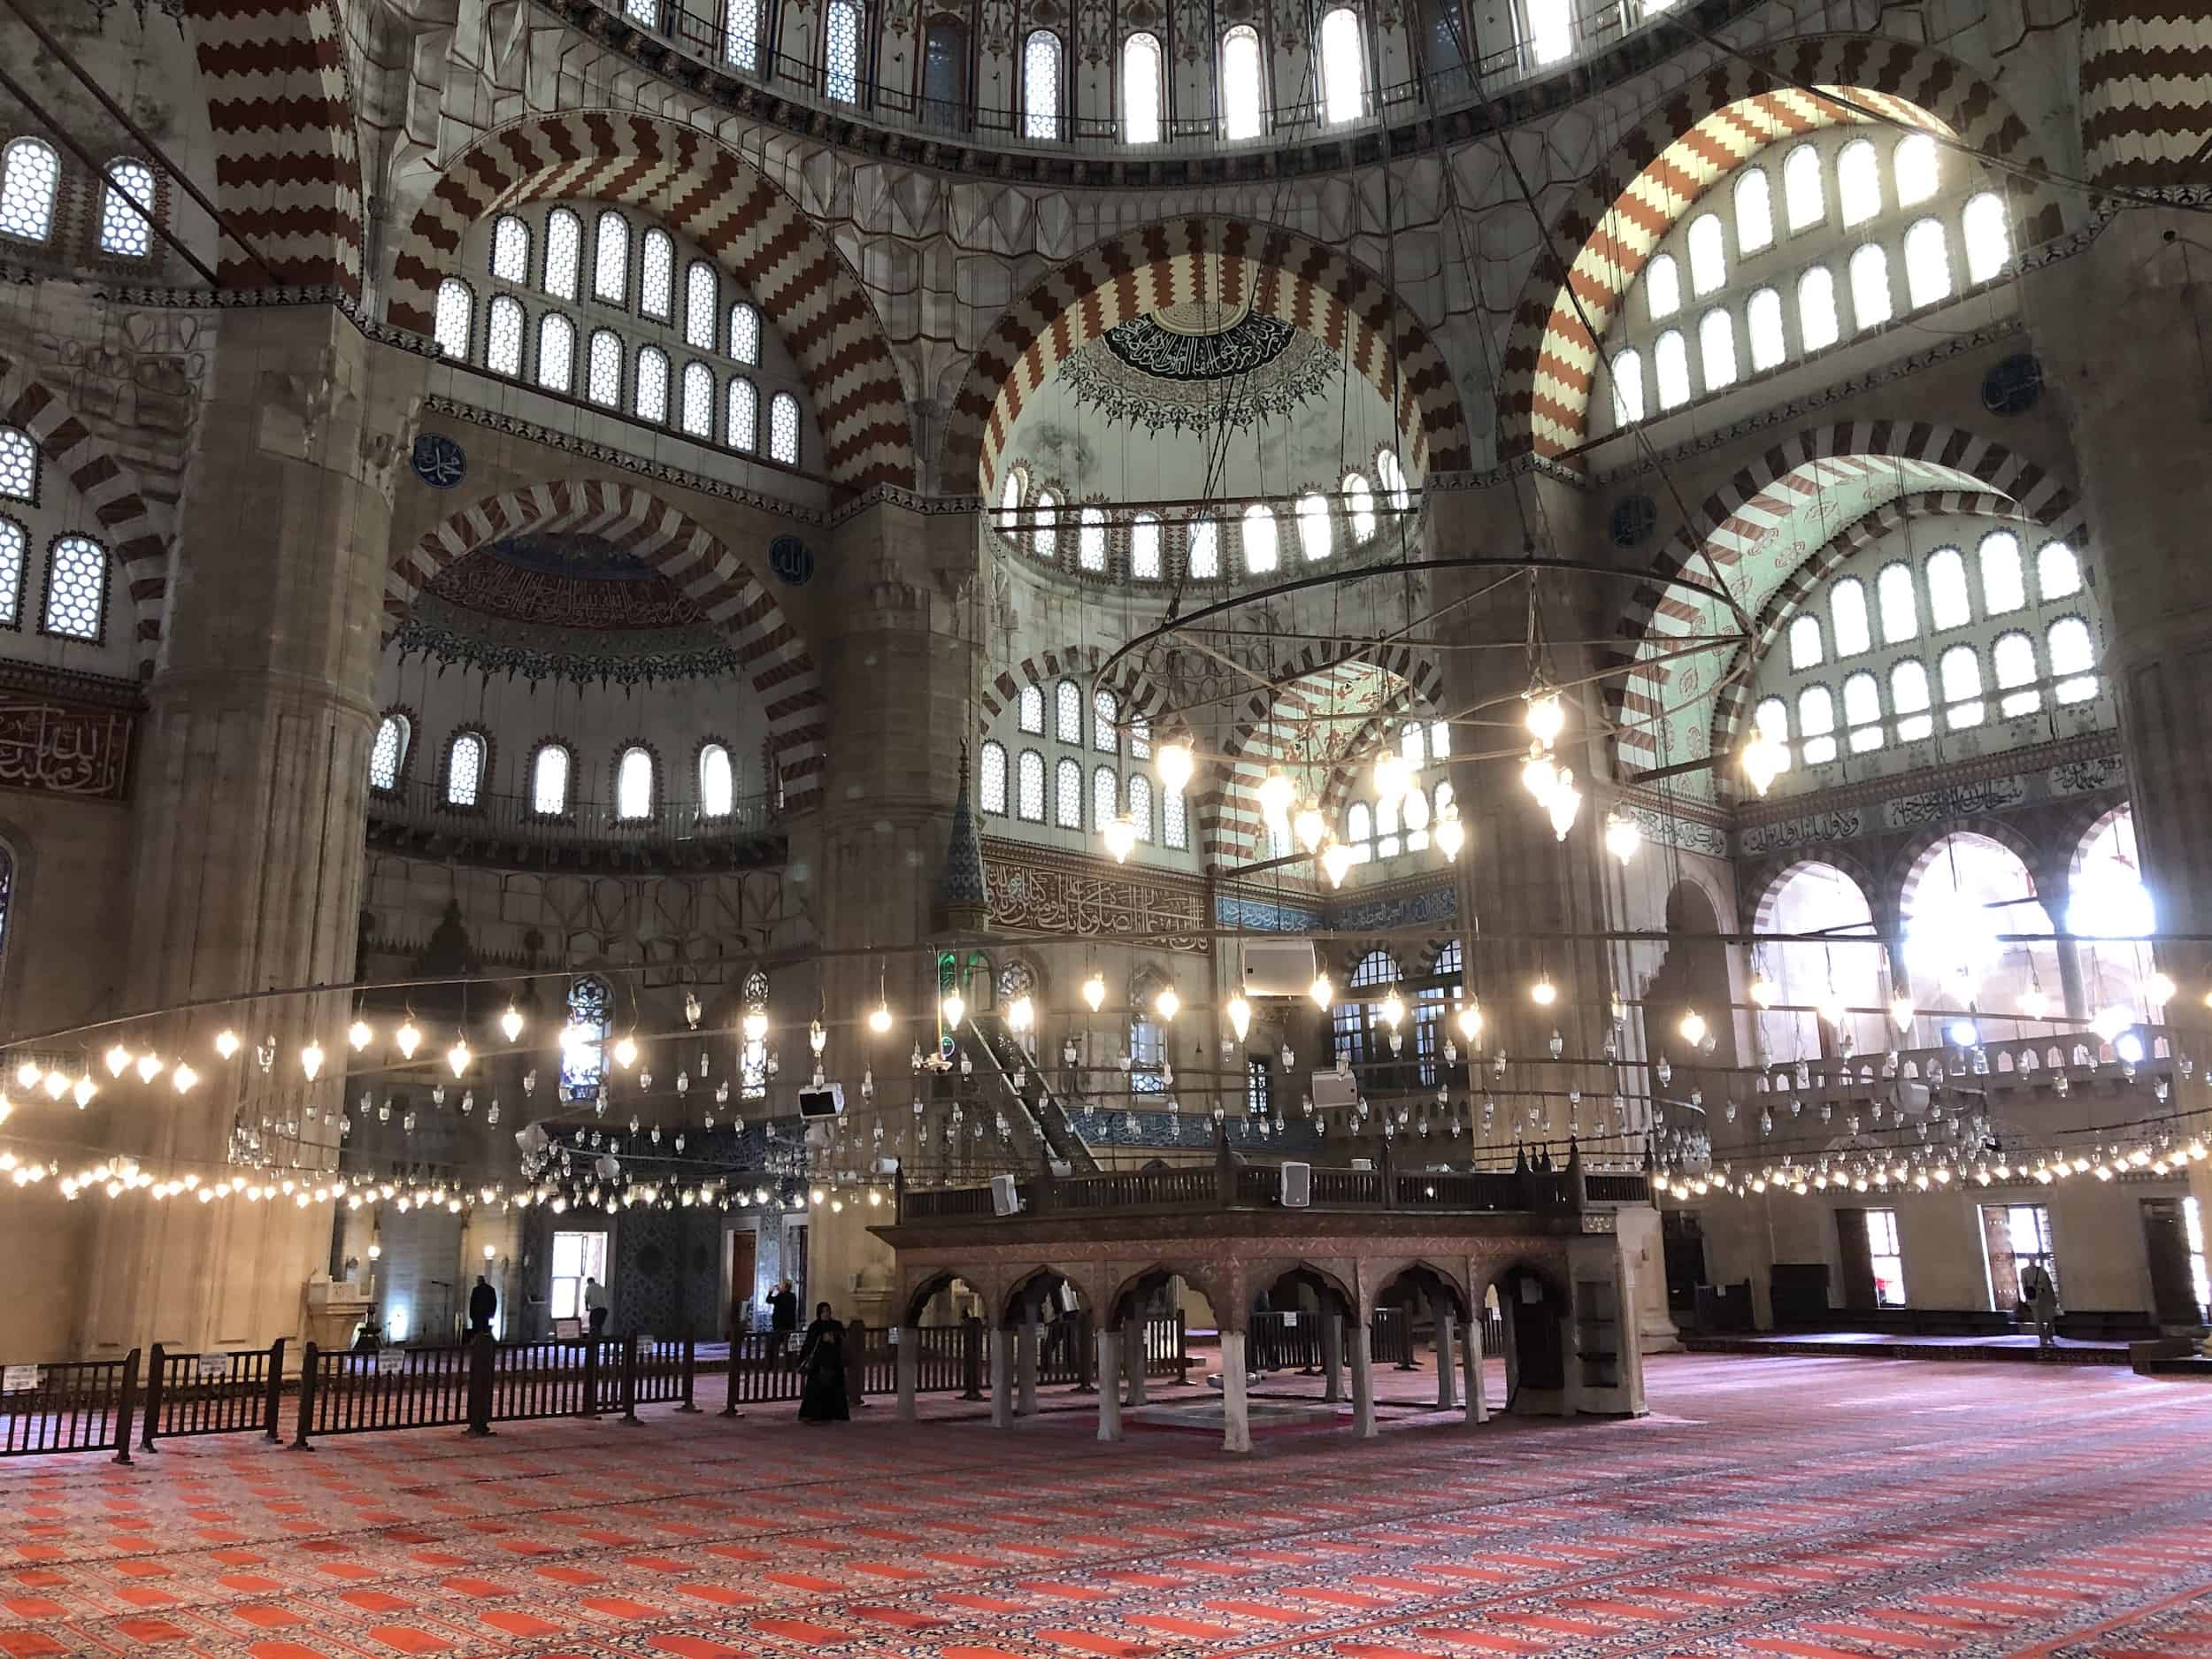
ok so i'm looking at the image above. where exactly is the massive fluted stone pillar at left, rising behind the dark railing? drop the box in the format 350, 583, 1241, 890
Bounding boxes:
82, 305, 420, 1354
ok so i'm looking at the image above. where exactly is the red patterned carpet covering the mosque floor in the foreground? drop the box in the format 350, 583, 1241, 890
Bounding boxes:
0, 1356, 2212, 1659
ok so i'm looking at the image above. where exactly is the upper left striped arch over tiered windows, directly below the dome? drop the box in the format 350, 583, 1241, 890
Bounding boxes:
385, 111, 914, 489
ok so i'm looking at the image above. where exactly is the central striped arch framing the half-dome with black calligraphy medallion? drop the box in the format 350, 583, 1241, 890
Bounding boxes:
942, 217, 1473, 495
